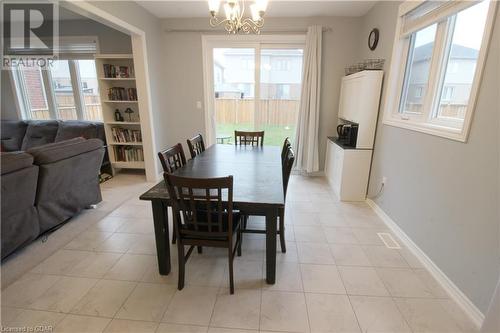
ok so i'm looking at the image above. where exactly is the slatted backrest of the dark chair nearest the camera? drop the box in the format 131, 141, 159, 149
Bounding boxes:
164, 173, 233, 238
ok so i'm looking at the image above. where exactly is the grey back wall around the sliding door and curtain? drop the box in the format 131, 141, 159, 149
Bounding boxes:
162, 17, 361, 169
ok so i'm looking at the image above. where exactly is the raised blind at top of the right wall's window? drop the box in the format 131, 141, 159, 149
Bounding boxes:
401, 0, 478, 37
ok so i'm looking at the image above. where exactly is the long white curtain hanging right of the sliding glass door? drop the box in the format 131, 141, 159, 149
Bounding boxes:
295, 26, 323, 173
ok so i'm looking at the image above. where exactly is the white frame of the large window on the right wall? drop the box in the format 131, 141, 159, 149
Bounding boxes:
382, 0, 497, 142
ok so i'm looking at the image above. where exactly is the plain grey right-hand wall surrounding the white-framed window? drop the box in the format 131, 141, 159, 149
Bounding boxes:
359, 2, 500, 313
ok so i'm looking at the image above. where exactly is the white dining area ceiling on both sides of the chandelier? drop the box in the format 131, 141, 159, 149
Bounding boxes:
136, 0, 376, 18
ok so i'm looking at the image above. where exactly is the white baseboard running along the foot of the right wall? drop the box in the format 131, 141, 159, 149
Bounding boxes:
366, 199, 484, 329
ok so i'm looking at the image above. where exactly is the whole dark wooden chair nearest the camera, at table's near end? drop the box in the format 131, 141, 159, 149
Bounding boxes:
164, 172, 241, 294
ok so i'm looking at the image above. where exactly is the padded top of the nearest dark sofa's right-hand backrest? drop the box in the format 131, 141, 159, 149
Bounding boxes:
27, 138, 103, 165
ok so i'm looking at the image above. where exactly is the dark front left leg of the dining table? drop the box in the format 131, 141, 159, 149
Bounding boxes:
151, 200, 170, 275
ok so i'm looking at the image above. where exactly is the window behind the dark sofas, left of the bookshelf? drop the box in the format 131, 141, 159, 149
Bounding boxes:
12, 59, 102, 121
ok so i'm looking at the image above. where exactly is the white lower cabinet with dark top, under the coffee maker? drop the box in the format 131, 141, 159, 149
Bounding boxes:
325, 139, 372, 201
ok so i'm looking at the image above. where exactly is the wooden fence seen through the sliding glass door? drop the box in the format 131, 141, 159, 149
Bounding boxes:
215, 98, 300, 126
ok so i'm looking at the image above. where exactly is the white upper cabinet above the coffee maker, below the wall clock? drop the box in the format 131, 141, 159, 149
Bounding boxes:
339, 71, 384, 149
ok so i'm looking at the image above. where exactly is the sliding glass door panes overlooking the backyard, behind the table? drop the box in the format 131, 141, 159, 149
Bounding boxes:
205, 37, 303, 146
